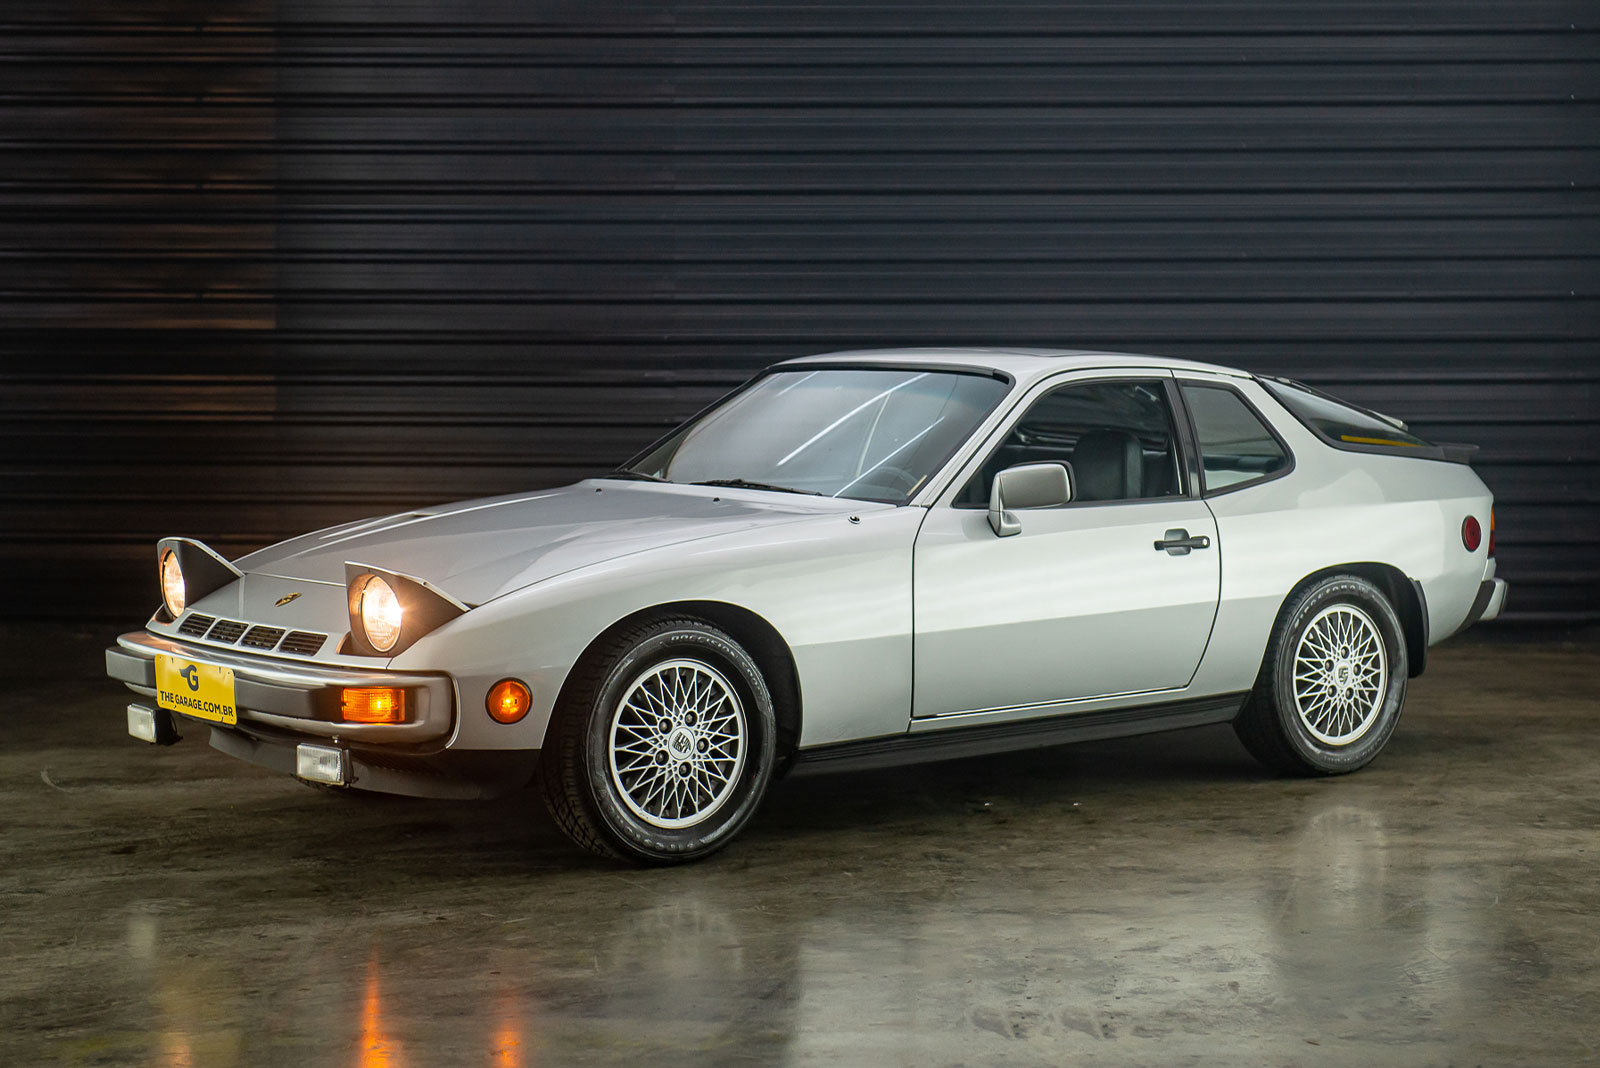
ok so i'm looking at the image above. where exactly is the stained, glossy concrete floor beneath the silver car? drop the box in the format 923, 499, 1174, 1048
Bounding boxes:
0, 628, 1600, 1068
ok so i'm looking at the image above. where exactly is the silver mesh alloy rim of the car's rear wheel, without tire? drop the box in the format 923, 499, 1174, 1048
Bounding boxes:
1294, 604, 1389, 745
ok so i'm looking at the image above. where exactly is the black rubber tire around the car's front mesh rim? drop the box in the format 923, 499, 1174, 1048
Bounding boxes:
539, 619, 778, 865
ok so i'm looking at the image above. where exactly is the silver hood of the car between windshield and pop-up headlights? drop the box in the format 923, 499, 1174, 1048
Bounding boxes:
235, 480, 870, 604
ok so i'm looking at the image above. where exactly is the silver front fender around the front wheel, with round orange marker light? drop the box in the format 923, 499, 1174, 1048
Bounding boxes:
390, 505, 925, 750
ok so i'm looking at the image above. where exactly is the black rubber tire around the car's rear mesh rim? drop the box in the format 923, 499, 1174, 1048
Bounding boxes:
1234, 574, 1410, 775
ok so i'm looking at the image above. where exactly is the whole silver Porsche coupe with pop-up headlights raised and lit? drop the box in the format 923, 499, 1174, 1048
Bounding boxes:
106, 350, 1506, 863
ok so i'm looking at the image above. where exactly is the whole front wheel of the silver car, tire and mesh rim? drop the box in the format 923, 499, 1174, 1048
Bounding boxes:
541, 619, 776, 863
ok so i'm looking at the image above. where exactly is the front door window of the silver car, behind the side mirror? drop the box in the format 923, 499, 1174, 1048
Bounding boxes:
955, 379, 1184, 507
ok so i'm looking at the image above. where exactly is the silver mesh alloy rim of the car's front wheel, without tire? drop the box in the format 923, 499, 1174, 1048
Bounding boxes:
610, 659, 749, 830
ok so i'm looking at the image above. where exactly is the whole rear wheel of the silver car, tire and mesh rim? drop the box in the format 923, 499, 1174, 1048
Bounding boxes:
1234, 576, 1408, 775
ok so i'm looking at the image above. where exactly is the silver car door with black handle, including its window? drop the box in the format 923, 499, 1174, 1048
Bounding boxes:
912, 373, 1221, 716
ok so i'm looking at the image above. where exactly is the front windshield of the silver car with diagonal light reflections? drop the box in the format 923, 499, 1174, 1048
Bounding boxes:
624, 368, 1008, 504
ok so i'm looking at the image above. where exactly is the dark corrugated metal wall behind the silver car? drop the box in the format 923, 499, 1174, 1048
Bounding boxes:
0, 0, 1600, 622
